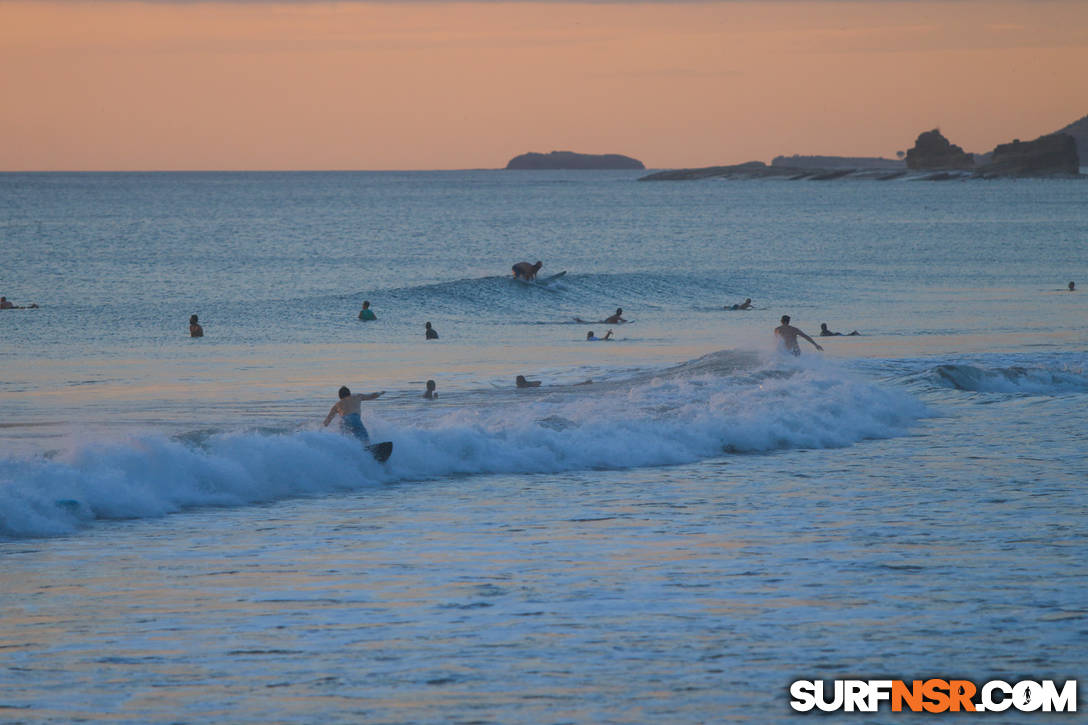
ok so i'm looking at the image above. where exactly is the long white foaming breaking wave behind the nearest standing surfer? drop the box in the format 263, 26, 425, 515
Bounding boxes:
0, 359, 925, 537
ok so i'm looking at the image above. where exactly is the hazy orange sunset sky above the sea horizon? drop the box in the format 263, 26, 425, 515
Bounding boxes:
0, 0, 1088, 171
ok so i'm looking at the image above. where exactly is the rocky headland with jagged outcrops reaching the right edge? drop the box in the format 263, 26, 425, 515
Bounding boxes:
639, 115, 1088, 181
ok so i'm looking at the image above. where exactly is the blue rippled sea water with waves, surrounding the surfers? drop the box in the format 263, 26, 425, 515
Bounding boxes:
0, 171, 1088, 723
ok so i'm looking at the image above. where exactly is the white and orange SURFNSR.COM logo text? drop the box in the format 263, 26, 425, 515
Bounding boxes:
790, 679, 1077, 712
